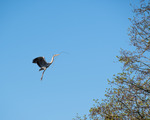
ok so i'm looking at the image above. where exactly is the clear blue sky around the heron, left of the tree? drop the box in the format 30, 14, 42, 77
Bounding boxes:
0, 0, 137, 120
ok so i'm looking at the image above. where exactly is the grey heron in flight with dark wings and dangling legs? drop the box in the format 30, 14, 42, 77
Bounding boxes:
32, 54, 60, 80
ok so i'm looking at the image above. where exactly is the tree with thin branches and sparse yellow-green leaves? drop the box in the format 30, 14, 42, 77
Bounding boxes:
74, 0, 150, 120
